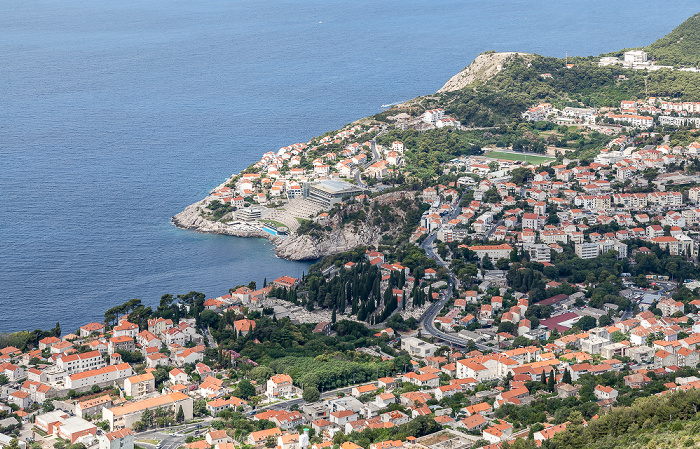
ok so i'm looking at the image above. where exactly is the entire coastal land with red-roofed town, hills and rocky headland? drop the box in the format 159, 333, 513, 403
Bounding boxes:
6, 10, 700, 449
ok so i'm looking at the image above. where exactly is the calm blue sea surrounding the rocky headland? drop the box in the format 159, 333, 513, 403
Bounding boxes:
0, 0, 698, 332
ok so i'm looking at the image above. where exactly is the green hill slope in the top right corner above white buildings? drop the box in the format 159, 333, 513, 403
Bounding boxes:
645, 13, 700, 67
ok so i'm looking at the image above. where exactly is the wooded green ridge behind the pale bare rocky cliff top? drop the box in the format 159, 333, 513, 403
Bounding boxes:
432, 55, 700, 126
